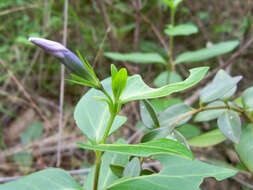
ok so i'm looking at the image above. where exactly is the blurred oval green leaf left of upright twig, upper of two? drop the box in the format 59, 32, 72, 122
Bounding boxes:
21, 121, 43, 144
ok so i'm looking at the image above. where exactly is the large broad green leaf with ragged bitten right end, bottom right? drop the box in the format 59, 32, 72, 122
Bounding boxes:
106, 155, 236, 190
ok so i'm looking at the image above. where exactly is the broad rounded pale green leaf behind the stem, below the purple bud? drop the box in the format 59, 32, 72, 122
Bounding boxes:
74, 78, 126, 142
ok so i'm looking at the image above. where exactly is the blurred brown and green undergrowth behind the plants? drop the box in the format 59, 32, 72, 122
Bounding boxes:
0, 0, 253, 189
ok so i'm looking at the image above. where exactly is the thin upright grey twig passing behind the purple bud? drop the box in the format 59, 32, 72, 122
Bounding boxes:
56, 0, 68, 167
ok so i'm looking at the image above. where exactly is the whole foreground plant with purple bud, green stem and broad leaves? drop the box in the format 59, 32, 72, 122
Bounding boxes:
0, 35, 238, 190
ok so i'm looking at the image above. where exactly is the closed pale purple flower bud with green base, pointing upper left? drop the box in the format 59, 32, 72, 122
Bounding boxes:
29, 37, 100, 87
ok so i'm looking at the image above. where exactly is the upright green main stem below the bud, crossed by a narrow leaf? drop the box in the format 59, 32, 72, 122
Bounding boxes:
93, 113, 117, 190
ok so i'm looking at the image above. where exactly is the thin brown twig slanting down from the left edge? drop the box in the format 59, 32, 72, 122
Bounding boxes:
0, 59, 48, 122
